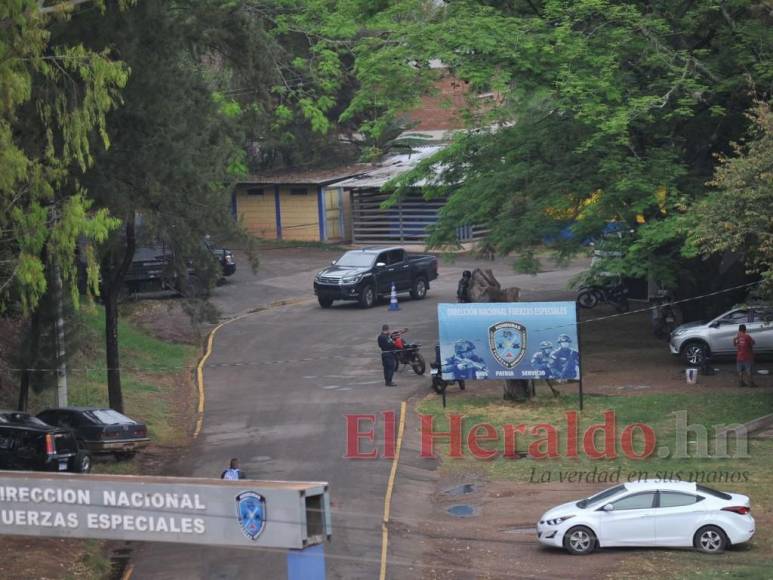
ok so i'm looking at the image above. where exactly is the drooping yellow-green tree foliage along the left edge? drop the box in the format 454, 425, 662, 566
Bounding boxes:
0, 0, 128, 311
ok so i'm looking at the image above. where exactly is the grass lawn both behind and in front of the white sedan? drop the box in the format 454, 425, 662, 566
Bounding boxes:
417, 390, 773, 578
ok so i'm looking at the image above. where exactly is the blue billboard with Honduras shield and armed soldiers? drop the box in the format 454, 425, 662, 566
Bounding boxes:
438, 302, 580, 381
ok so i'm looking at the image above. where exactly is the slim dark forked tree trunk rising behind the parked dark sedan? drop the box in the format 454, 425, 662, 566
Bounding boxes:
102, 214, 136, 413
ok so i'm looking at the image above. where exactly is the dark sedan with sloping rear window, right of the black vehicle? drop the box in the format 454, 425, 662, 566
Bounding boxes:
38, 407, 150, 459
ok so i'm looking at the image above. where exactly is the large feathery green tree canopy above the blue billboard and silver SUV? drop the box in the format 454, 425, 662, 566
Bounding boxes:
284, 0, 773, 286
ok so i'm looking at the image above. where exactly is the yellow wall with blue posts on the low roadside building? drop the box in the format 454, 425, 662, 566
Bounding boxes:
236, 185, 342, 241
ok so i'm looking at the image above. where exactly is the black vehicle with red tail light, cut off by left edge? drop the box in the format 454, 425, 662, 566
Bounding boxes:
0, 411, 91, 473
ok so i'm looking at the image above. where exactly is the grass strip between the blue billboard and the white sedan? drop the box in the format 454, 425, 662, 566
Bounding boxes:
418, 392, 773, 486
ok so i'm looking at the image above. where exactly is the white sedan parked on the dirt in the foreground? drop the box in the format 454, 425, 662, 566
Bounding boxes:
537, 480, 755, 554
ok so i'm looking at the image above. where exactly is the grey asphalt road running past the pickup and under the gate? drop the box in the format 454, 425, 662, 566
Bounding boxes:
133, 250, 582, 580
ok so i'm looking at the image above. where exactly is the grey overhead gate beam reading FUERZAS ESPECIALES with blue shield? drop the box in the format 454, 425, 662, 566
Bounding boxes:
0, 472, 330, 549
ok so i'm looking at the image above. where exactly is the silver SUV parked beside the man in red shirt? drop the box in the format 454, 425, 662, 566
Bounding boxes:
668, 304, 773, 366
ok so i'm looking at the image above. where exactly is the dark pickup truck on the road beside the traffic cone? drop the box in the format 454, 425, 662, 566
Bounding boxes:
314, 248, 437, 308
